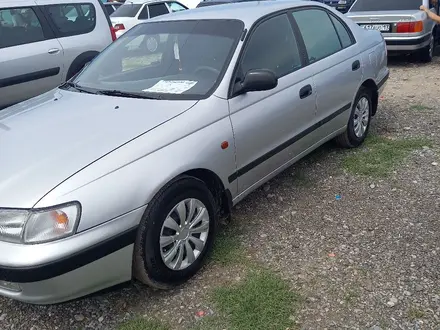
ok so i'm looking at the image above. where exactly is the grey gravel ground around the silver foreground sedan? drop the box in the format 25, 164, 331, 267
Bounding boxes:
0, 58, 440, 330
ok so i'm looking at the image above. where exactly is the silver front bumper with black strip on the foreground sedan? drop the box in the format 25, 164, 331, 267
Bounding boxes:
0, 207, 145, 304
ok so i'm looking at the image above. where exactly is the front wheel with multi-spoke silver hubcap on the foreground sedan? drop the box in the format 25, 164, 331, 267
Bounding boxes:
133, 176, 218, 289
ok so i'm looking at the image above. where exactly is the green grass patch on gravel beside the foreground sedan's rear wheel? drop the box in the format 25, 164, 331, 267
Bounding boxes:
343, 136, 431, 177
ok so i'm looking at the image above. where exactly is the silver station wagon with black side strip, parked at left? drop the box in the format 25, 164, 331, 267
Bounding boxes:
0, 0, 116, 109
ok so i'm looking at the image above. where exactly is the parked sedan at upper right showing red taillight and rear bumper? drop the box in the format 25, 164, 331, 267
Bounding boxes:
346, 0, 440, 62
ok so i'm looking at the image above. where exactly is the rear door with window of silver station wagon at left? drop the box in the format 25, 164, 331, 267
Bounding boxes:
0, 1, 63, 108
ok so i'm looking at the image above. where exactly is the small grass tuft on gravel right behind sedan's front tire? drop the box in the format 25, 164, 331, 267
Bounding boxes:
210, 227, 244, 266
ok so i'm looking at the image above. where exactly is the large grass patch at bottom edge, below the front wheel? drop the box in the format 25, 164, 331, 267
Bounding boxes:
203, 270, 299, 330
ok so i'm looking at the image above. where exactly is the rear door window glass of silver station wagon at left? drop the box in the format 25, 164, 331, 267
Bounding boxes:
0, 8, 44, 49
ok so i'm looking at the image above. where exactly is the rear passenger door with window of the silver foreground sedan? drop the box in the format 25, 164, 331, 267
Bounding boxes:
292, 7, 362, 139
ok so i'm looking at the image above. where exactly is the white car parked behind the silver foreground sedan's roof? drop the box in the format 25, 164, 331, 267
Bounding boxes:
110, 0, 188, 38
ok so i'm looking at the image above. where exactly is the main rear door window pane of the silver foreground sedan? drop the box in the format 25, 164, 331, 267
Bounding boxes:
292, 9, 342, 63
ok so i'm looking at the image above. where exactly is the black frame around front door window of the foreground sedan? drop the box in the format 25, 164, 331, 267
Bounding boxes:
227, 8, 307, 100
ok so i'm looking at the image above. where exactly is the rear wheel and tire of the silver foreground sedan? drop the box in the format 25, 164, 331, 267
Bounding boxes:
335, 87, 373, 148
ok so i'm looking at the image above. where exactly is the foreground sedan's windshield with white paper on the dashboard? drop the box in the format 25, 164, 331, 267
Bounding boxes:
73, 19, 244, 100
